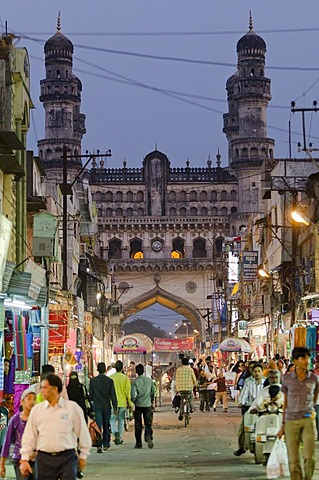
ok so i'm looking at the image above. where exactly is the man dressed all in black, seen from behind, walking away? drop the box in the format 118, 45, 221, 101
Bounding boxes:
89, 362, 117, 453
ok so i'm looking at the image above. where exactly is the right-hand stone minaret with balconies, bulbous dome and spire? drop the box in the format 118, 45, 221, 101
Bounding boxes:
223, 16, 275, 213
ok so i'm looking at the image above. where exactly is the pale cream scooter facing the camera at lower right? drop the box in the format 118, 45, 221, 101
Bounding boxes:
254, 402, 282, 465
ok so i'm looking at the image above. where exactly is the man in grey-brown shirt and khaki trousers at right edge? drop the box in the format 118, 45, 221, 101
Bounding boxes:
278, 347, 319, 480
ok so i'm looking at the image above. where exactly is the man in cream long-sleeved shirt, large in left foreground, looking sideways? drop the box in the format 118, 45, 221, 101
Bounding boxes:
20, 373, 91, 480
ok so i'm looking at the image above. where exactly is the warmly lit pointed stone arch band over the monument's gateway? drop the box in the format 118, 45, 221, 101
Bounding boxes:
121, 286, 203, 333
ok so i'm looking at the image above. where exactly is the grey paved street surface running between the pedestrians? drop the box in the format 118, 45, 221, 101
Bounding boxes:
7, 394, 319, 480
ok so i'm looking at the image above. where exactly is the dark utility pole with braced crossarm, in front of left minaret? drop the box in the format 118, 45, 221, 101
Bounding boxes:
62, 145, 112, 291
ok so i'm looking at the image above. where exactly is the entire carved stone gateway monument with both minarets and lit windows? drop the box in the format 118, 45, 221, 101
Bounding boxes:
39, 16, 274, 333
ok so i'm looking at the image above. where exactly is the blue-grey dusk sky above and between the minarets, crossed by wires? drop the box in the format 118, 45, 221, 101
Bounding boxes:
0, 0, 319, 172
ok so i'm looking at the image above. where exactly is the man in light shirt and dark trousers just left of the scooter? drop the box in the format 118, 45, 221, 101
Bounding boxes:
234, 362, 266, 457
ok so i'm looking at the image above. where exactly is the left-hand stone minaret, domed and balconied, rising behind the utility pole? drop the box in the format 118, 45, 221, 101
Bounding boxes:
38, 14, 86, 178
